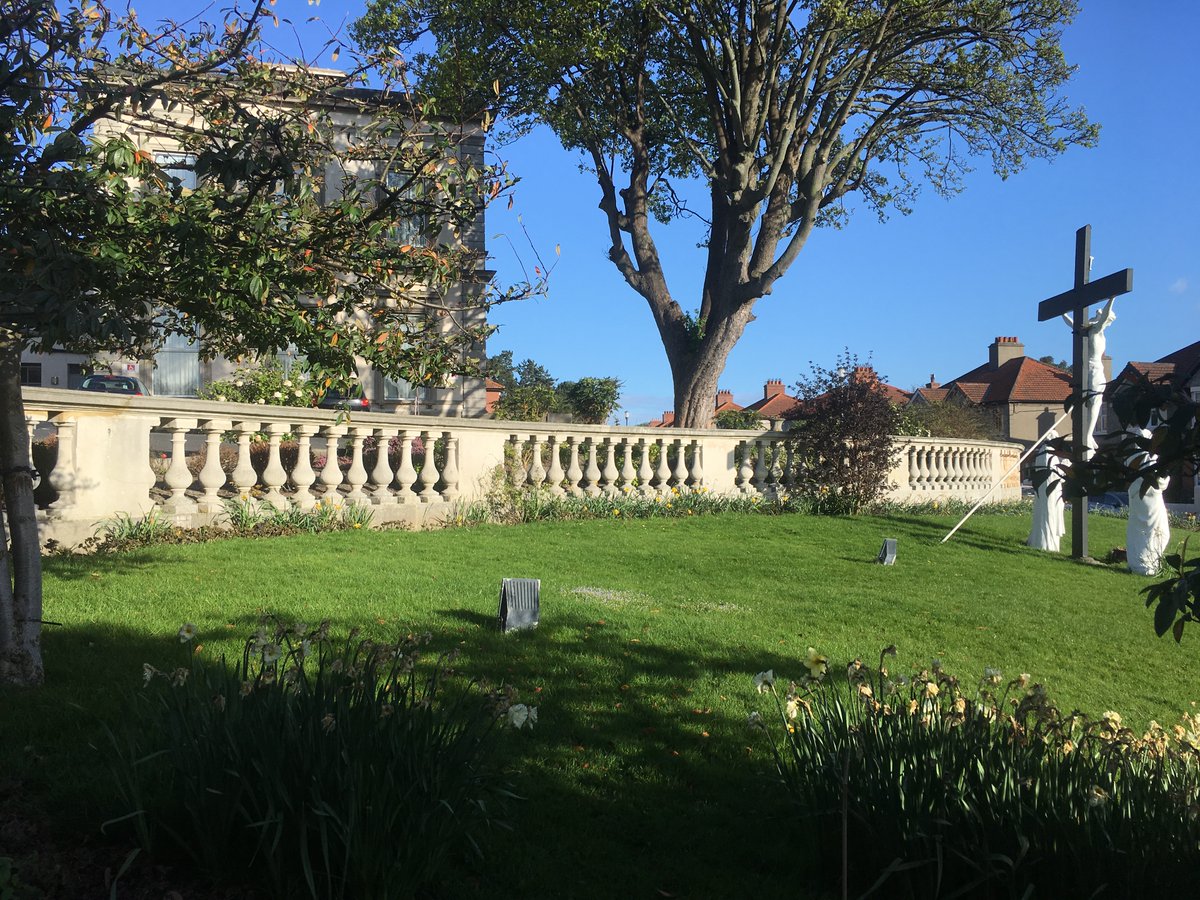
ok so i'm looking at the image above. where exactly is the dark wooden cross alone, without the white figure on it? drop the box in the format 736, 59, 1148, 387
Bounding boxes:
1038, 226, 1133, 559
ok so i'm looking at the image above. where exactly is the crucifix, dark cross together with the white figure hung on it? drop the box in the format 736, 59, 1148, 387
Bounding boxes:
1038, 226, 1133, 559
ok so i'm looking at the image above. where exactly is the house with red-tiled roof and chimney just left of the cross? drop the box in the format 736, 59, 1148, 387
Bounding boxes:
912, 337, 1084, 446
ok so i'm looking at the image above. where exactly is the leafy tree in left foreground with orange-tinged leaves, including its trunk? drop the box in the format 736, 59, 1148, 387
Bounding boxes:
0, 0, 523, 684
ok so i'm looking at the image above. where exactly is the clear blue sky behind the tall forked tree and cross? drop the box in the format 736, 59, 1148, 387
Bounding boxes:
138, 0, 1200, 422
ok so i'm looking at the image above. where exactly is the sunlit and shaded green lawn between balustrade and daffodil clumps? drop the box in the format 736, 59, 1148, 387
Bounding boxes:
0, 515, 1200, 898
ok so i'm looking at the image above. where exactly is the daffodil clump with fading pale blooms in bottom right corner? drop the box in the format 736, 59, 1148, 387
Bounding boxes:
751, 647, 1200, 898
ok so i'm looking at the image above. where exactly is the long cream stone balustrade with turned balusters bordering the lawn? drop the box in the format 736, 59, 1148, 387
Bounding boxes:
16, 389, 1020, 544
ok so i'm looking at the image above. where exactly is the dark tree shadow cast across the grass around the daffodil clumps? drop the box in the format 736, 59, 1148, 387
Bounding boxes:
0, 610, 817, 898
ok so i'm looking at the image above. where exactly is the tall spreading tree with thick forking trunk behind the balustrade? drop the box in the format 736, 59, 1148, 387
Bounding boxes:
355, 0, 1097, 427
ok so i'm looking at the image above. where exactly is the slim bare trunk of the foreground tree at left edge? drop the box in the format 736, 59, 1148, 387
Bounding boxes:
0, 334, 46, 686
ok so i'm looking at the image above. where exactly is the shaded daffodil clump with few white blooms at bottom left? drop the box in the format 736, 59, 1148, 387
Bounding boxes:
108, 623, 535, 900
